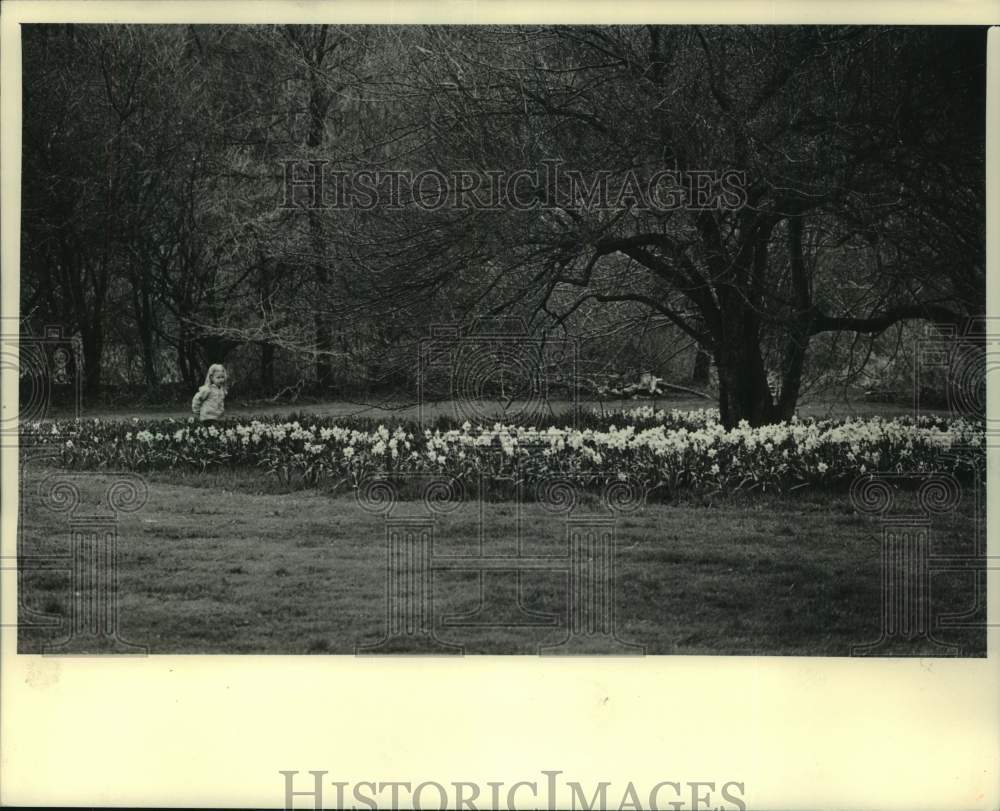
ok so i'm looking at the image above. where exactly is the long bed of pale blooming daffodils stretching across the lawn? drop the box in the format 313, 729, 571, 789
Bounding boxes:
22, 407, 985, 492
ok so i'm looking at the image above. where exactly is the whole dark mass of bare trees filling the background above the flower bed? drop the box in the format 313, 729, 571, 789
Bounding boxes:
21, 25, 985, 424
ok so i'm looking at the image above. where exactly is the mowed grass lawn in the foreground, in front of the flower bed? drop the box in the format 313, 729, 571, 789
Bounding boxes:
19, 465, 986, 656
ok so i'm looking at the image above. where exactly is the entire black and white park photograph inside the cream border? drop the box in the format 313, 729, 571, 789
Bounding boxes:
11, 23, 988, 658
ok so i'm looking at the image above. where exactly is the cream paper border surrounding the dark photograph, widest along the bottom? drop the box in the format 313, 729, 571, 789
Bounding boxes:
0, 0, 1000, 810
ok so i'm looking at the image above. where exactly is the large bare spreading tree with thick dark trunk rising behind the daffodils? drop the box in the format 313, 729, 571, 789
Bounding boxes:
386, 27, 985, 425
